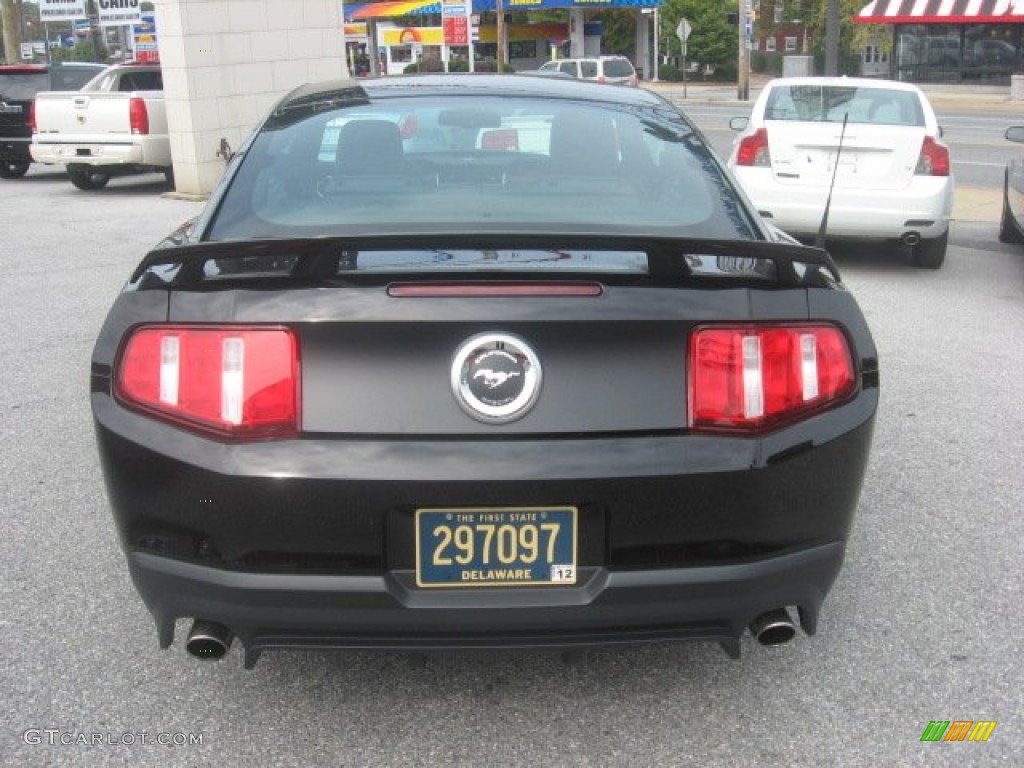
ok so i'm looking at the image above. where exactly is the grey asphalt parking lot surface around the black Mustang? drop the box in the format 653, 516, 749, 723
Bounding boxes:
0, 169, 1024, 768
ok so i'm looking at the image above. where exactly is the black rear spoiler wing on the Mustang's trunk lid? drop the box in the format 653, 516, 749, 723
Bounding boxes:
130, 233, 841, 290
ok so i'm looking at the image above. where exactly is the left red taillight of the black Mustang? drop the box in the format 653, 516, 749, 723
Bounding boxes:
116, 326, 299, 438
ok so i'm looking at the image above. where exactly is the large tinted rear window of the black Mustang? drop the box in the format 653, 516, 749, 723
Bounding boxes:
205, 95, 759, 240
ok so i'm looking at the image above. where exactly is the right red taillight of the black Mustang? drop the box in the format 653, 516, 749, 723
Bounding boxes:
689, 326, 856, 432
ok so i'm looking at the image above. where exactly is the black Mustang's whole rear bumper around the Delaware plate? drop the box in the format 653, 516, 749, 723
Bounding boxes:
92, 388, 878, 665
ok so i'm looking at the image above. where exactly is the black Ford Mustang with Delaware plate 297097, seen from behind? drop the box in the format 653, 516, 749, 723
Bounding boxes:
91, 78, 878, 665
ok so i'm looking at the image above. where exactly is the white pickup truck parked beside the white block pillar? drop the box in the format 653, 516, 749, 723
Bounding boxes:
31, 65, 174, 189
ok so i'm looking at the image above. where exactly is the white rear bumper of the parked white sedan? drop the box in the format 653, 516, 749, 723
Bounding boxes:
734, 168, 953, 240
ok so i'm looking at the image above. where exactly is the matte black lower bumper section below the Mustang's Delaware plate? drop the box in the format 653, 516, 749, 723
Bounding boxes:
128, 542, 844, 667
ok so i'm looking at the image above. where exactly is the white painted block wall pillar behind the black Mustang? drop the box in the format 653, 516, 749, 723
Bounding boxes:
156, 0, 348, 197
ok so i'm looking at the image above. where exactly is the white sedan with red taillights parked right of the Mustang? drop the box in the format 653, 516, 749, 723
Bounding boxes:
729, 78, 953, 269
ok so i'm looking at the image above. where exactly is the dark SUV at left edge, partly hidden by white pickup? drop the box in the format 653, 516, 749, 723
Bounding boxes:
0, 61, 106, 178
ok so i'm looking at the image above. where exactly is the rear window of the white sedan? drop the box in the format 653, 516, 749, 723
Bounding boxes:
765, 85, 925, 126
